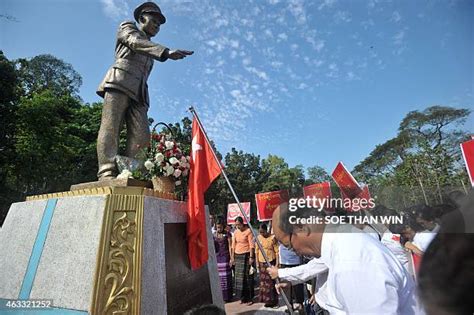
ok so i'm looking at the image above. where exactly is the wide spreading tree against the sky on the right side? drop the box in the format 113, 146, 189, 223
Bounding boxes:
354, 106, 470, 208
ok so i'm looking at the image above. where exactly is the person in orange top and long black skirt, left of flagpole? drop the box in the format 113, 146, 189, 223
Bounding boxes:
231, 217, 255, 305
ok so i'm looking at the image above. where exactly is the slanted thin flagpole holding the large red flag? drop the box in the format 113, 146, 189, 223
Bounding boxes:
189, 106, 294, 315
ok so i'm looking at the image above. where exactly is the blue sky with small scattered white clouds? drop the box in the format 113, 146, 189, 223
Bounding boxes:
0, 0, 474, 172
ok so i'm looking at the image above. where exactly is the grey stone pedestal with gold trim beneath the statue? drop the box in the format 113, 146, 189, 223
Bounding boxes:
0, 187, 224, 315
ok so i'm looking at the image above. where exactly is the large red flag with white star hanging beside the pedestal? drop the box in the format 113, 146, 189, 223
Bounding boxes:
187, 118, 221, 270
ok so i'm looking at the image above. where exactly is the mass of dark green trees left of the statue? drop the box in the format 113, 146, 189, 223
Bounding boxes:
0, 53, 98, 222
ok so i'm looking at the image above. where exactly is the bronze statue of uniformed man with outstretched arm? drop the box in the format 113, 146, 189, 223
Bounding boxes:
97, 2, 193, 180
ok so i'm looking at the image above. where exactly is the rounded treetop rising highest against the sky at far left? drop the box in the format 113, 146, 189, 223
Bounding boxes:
16, 55, 82, 98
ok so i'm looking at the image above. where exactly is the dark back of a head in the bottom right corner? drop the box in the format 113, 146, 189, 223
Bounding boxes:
418, 233, 474, 315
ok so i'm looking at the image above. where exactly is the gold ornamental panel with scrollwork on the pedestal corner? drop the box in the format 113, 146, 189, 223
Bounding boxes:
91, 189, 144, 315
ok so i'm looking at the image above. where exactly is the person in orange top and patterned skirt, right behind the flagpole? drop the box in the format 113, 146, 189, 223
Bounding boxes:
255, 223, 279, 307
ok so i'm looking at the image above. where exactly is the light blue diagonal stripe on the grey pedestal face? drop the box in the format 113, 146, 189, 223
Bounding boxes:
18, 198, 58, 300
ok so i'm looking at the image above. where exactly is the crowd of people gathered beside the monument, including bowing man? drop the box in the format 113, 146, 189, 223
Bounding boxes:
211, 193, 474, 315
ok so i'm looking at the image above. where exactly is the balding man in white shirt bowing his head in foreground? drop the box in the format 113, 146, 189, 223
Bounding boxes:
273, 204, 420, 315
